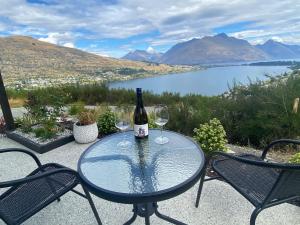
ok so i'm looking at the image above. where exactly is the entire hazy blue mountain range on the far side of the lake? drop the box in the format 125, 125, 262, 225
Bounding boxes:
123, 33, 300, 65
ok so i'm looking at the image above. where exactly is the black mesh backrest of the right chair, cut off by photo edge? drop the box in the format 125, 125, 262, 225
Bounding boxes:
265, 169, 300, 204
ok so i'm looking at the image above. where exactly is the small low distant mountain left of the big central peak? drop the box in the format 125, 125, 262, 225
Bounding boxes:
122, 50, 162, 62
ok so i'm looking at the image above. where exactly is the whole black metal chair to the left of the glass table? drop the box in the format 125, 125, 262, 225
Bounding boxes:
0, 148, 101, 225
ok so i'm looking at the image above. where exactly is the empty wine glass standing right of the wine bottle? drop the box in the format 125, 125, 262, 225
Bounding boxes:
154, 105, 169, 145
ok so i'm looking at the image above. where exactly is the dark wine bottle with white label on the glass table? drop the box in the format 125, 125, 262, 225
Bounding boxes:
133, 88, 148, 139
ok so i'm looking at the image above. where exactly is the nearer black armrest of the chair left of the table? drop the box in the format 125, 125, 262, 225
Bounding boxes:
0, 168, 80, 188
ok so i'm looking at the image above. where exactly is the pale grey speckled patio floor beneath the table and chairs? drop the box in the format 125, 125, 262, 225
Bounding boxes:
0, 138, 300, 225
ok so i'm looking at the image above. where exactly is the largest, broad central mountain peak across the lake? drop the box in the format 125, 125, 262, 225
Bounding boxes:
160, 33, 269, 65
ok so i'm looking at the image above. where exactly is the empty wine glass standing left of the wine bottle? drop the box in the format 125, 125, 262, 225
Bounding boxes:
115, 108, 131, 148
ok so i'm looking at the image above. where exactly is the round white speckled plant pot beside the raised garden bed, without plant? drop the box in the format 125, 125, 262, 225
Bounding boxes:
73, 123, 98, 144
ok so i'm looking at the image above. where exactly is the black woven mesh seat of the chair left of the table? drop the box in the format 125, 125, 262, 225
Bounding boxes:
0, 163, 78, 224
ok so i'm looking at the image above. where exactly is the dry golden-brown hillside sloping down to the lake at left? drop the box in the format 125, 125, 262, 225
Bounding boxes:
0, 36, 188, 86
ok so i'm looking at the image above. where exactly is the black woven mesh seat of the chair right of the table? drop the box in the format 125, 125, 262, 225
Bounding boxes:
212, 154, 279, 206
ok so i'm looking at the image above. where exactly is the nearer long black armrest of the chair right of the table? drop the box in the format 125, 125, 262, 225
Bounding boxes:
214, 152, 300, 170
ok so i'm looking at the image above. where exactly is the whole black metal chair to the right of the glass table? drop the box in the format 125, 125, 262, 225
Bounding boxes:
196, 139, 300, 225
